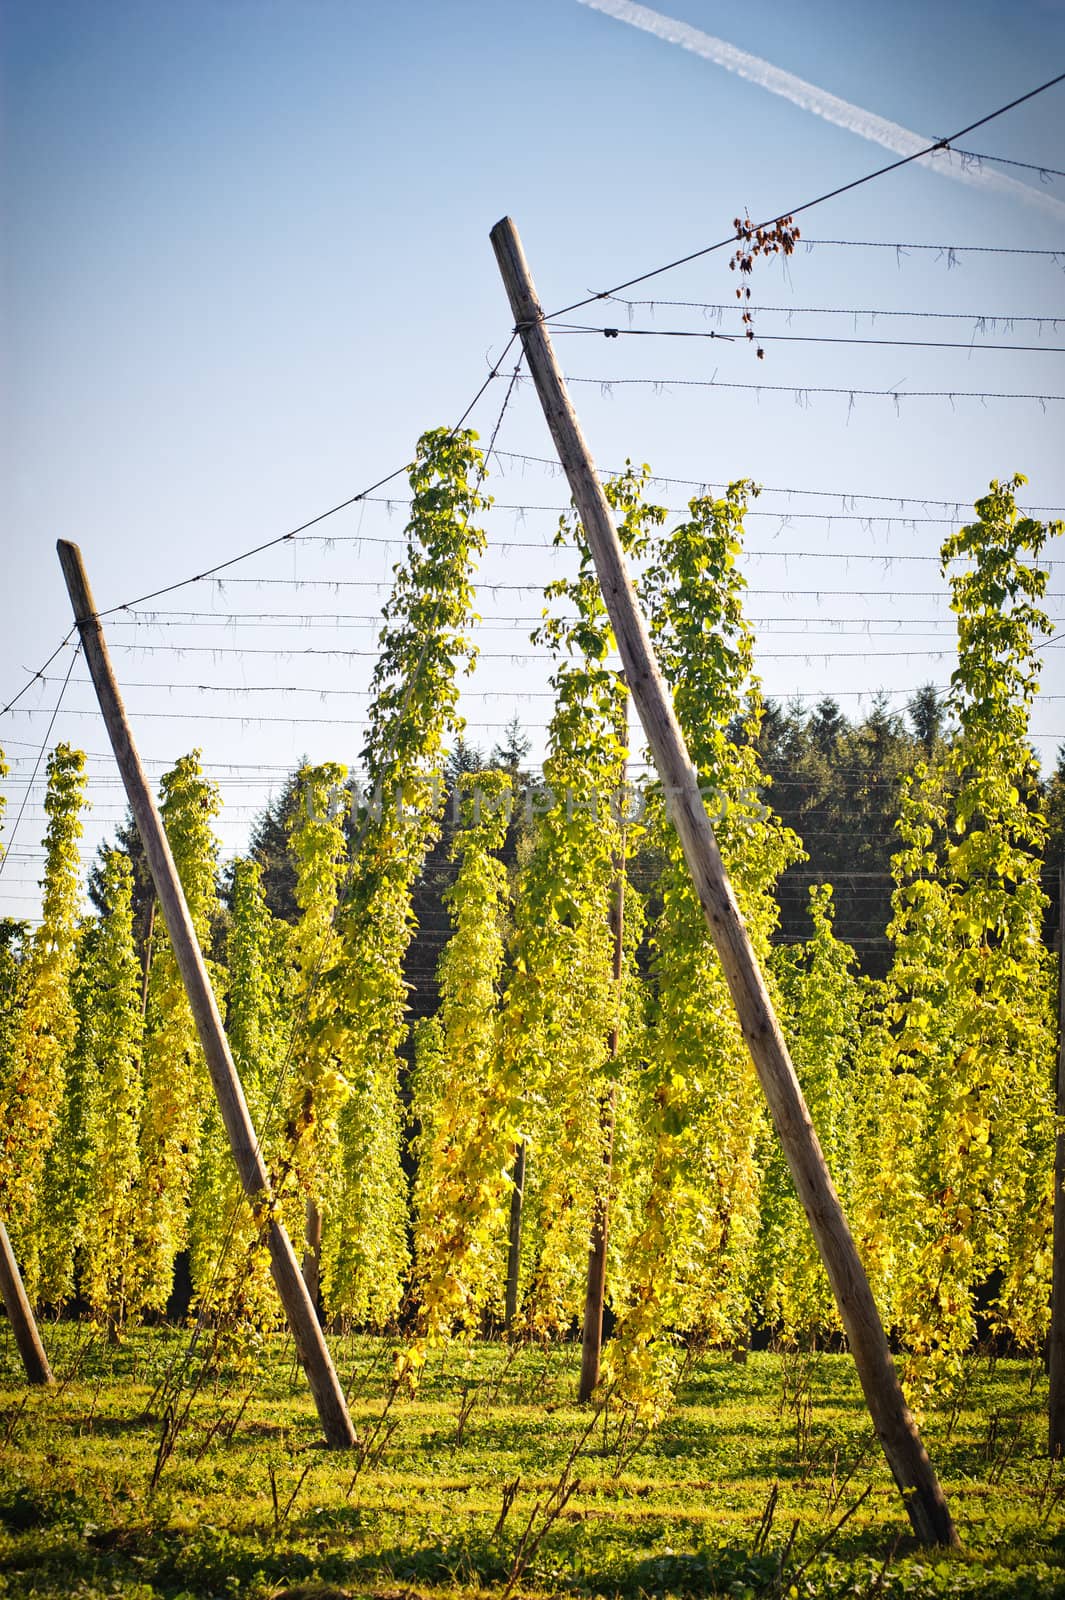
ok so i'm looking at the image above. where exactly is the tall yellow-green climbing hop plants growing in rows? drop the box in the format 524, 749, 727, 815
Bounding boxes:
0, 432, 1062, 1419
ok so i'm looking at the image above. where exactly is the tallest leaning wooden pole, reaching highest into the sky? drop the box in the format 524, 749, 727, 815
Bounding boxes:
491, 218, 959, 1546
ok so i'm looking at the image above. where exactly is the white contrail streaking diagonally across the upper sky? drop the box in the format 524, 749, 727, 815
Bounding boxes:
580, 0, 1065, 218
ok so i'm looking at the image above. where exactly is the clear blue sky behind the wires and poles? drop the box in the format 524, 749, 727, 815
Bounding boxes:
0, 0, 1065, 912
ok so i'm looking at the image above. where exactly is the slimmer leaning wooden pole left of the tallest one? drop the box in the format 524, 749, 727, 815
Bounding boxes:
56, 539, 355, 1450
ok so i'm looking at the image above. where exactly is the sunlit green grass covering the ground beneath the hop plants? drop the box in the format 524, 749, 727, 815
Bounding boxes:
0, 1325, 1065, 1600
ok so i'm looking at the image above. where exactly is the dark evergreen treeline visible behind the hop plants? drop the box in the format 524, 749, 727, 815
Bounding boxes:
76, 685, 1065, 1019
